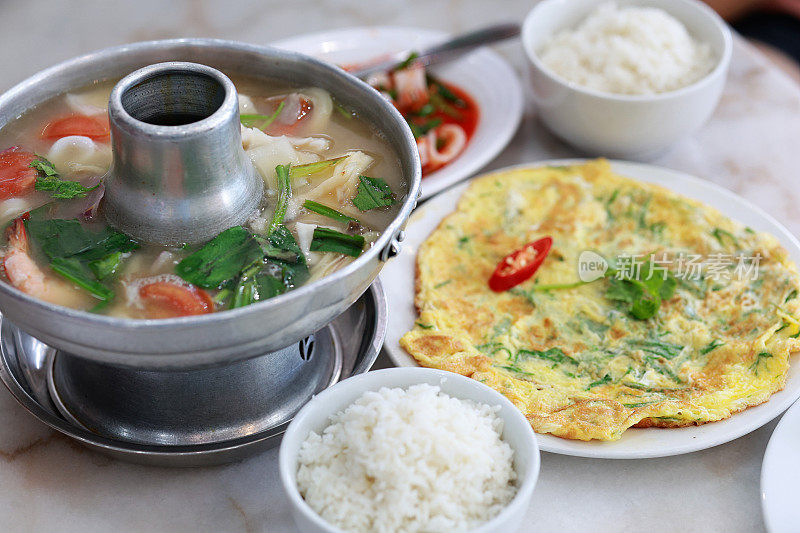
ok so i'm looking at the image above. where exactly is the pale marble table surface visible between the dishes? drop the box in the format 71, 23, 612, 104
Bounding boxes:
0, 0, 800, 533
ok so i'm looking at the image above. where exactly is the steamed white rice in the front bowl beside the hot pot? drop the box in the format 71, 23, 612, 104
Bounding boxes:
297, 384, 516, 532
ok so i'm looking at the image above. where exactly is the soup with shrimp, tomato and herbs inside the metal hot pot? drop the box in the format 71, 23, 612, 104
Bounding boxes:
0, 78, 405, 318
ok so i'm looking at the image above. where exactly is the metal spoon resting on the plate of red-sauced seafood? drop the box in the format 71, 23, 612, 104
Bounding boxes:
350, 24, 520, 78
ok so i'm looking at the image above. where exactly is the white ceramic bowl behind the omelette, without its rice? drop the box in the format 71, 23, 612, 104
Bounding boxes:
522, 0, 732, 159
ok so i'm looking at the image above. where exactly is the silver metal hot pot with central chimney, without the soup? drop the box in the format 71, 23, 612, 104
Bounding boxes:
0, 39, 421, 465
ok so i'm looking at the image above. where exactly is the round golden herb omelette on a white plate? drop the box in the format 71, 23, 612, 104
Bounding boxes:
400, 160, 800, 440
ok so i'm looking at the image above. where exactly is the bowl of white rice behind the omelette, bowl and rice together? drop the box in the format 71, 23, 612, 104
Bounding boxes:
522, 0, 732, 159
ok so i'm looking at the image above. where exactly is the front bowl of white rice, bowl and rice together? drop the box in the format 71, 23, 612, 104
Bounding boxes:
279, 368, 539, 533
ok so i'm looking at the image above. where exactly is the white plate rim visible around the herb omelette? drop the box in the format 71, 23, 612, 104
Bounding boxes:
380, 159, 800, 459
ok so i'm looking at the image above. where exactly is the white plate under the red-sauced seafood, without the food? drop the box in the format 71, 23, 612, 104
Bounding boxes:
271, 26, 523, 199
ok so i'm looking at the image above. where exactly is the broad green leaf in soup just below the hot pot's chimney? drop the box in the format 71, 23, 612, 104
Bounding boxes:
175, 226, 264, 289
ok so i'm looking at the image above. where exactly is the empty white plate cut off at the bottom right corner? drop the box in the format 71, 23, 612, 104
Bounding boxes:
761, 396, 800, 533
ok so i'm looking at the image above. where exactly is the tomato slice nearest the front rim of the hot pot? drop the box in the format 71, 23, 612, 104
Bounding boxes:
139, 281, 214, 318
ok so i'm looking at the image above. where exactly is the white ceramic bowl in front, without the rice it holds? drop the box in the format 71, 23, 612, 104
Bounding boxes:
278, 368, 539, 533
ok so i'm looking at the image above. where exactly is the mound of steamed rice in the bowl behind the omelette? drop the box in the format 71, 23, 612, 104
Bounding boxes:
538, 3, 715, 94
